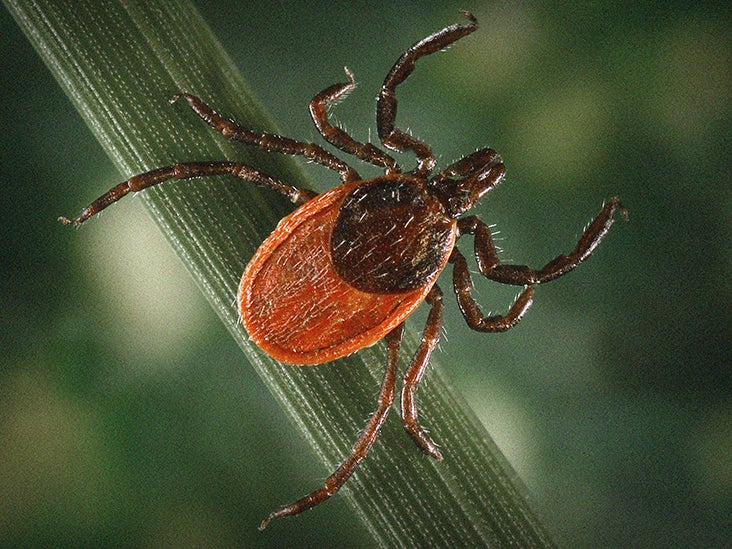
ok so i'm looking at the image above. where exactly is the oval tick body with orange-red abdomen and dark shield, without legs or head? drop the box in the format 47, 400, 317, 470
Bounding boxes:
239, 174, 457, 364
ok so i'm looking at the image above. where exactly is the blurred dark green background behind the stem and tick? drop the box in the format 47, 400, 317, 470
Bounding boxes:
0, 1, 732, 547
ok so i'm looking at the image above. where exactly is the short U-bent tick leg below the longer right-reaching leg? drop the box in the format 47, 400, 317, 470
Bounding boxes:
450, 248, 534, 332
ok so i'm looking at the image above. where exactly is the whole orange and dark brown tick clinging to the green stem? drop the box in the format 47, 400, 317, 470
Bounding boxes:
60, 13, 627, 529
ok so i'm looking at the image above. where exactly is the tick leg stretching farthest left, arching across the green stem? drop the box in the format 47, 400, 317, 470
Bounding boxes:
59, 161, 316, 225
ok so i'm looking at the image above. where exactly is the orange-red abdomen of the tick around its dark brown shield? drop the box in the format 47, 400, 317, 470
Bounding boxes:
238, 177, 455, 364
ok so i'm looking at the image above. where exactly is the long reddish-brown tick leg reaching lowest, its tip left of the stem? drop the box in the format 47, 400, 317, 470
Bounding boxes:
259, 323, 404, 530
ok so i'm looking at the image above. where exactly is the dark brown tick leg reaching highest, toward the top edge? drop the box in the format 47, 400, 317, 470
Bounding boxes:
376, 12, 478, 176
